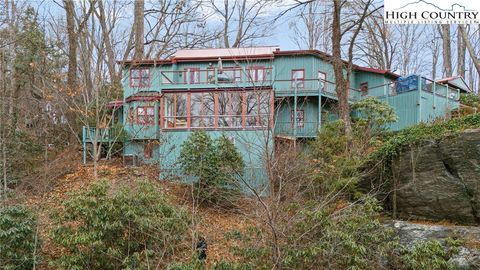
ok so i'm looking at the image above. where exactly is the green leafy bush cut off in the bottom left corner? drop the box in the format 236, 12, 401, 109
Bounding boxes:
0, 205, 40, 270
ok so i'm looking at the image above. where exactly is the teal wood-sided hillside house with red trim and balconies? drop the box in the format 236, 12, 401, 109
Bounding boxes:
83, 46, 469, 193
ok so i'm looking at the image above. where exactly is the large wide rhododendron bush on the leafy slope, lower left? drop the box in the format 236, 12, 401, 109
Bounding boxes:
51, 181, 188, 269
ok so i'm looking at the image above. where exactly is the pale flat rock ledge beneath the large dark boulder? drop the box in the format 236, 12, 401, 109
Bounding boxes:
387, 221, 480, 270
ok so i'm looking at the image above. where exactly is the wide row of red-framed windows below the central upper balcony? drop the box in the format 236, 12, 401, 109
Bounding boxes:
163, 91, 272, 128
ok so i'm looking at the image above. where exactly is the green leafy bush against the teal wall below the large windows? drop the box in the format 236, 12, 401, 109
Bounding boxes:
179, 131, 245, 206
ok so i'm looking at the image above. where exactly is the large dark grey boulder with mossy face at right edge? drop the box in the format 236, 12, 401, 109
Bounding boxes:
389, 129, 480, 224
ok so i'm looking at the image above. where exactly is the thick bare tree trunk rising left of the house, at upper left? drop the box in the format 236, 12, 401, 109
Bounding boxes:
63, 0, 77, 89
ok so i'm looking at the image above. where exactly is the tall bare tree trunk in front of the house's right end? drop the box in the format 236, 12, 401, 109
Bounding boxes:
332, 0, 352, 134
